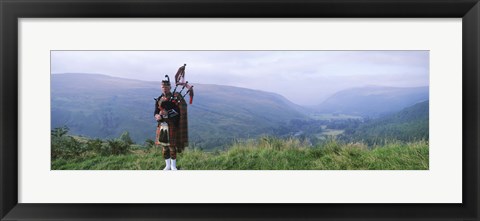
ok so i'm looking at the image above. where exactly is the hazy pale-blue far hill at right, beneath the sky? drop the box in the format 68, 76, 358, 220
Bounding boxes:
315, 86, 429, 117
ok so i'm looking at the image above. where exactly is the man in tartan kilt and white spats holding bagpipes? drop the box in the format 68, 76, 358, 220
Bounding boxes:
154, 66, 193, 170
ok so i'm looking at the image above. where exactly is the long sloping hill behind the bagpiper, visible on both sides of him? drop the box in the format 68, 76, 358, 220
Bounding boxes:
51, 74, 306, 148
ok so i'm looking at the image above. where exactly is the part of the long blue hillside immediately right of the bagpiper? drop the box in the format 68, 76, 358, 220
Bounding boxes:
189, 84, 306, 146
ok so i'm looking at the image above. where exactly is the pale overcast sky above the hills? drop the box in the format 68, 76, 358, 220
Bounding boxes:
51, 51, 429, 105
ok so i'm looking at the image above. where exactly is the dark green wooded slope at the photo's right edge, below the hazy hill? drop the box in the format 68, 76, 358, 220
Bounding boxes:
342, 101, 429, 144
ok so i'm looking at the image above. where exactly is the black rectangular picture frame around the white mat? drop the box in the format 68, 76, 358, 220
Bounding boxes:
0, 0, 480, 221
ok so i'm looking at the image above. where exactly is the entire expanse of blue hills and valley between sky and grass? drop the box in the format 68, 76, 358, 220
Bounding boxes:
51, 74, 428, 151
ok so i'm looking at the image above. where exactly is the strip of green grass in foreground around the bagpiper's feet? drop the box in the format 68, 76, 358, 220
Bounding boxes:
52, 137, 429, 170
